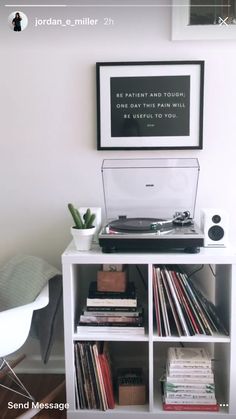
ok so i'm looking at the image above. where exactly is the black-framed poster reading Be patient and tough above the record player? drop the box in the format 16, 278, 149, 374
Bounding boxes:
96, 61, 204, 150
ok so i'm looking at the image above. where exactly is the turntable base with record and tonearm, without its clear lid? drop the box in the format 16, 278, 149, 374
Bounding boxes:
98, 218, 204, 253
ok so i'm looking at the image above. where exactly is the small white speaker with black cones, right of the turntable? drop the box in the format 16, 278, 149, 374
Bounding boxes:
201, 208, 229, 247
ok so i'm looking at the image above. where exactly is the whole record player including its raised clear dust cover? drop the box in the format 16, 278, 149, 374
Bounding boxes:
98, 158, 204, 253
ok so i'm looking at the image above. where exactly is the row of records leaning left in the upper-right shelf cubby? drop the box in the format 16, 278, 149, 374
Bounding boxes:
153, 266, 228, 336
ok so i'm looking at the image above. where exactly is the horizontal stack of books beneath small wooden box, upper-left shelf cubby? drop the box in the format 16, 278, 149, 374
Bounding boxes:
77, 281, 145, 335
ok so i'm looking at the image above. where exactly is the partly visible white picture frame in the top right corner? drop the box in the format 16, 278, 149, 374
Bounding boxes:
171, 0, 236, 41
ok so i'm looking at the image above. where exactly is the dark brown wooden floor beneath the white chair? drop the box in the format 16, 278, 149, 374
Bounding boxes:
0, 374, 66, 419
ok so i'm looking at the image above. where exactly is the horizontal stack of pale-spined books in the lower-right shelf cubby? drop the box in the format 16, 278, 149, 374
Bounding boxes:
163, 348, 219, 412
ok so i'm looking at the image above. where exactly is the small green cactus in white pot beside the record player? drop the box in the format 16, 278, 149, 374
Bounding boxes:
68, 203, 96, 250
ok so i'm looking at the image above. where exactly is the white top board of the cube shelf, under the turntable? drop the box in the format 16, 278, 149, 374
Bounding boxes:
62, 241, 236, 264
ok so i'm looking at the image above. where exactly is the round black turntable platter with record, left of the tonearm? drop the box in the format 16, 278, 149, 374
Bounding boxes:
109, 218, 163, 232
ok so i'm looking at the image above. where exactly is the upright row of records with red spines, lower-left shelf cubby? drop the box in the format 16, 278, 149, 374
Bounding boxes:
74, 342, 115, 410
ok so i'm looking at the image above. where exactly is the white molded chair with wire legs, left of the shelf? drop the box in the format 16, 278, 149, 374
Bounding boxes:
0, 283, 49, 400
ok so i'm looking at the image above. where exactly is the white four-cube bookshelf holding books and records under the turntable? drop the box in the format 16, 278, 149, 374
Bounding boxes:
62, 243, 236, 419
